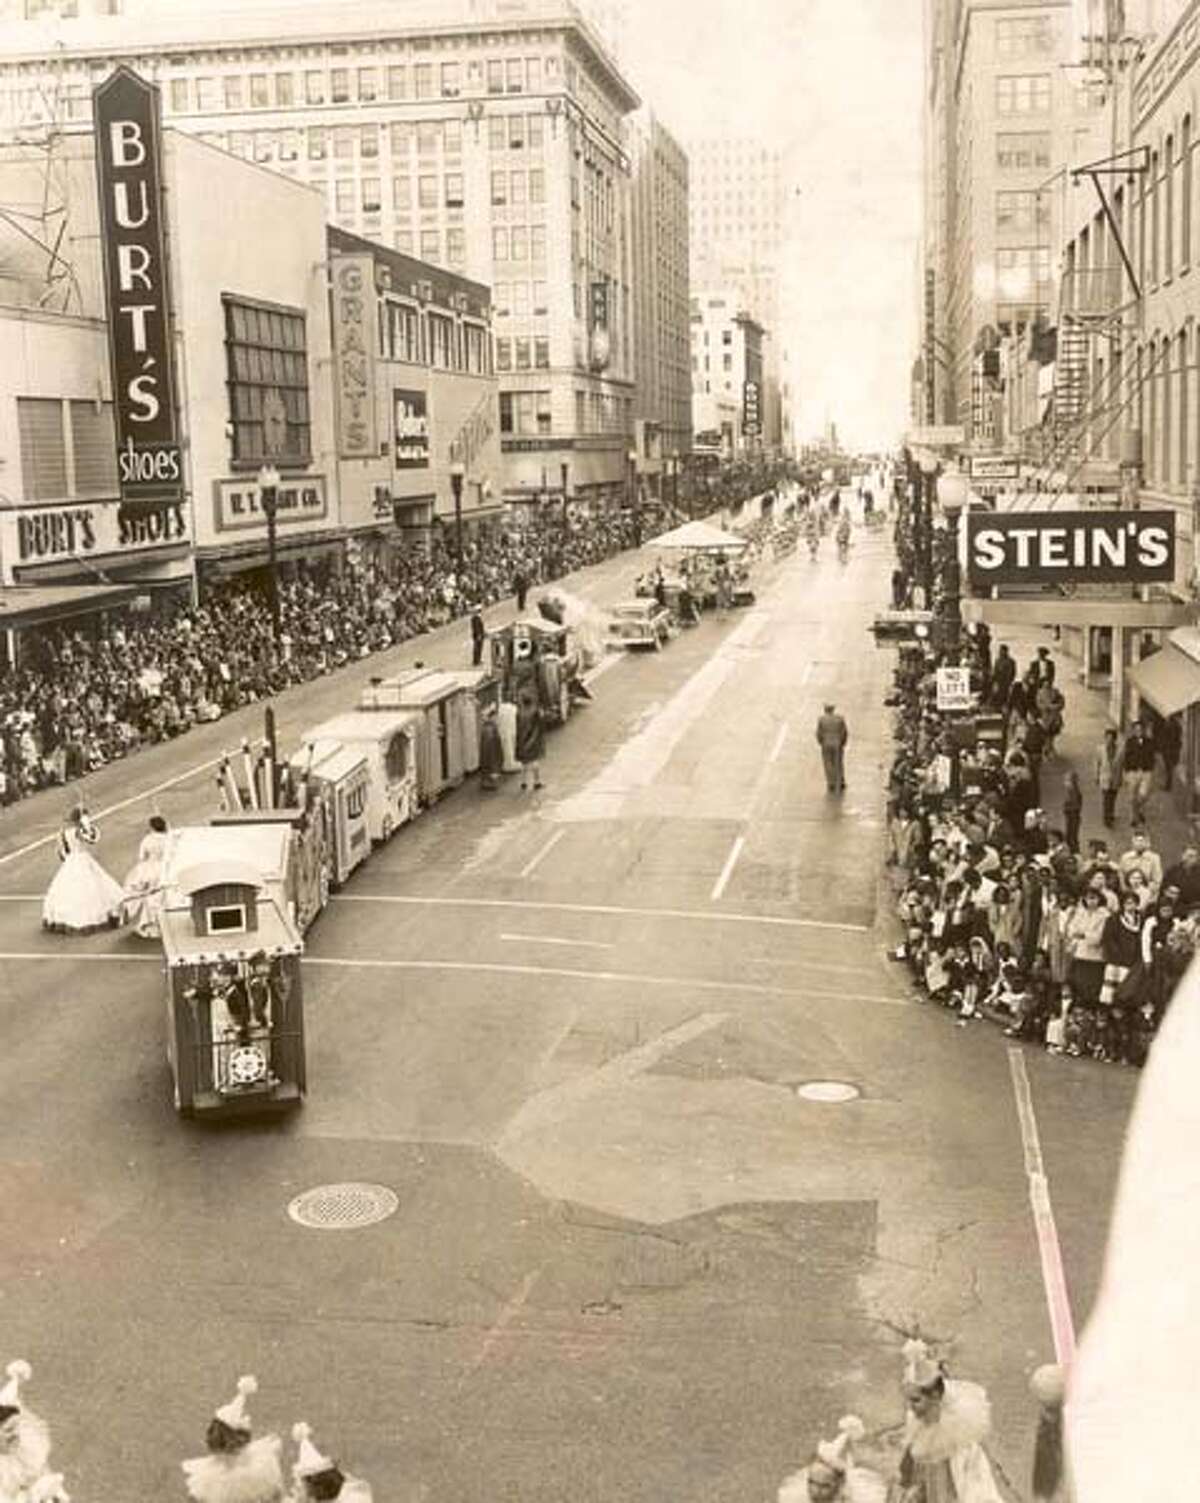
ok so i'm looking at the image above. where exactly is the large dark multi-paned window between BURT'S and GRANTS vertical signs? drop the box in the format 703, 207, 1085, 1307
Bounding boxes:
223, 296, 313, 466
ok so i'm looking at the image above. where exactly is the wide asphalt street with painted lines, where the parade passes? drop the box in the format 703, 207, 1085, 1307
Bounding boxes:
0, 511, 1135, 1503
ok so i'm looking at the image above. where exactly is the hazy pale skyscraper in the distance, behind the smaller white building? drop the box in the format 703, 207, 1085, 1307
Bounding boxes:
687, 137, 788, 446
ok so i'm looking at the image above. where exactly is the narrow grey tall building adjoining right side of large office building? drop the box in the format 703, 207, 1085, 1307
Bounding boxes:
630, 110, 692, 496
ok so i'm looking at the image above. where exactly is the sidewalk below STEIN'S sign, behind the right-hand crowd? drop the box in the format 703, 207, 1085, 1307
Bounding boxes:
992, 627, 1188, 867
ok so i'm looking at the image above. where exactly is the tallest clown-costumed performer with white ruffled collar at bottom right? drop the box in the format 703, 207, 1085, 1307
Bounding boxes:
899, 1341, 1003, 1503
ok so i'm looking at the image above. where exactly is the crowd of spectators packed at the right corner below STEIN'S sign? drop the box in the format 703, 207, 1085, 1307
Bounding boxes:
889, 568, 1200, 1066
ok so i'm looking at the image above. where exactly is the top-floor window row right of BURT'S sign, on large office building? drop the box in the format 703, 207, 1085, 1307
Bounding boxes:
167, 57, 559, 114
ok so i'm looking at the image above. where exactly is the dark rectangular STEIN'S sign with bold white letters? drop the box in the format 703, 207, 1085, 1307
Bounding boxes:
967, 511, 1174, 589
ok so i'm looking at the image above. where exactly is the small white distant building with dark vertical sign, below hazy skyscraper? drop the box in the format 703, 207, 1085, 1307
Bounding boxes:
692, 287, 765, 458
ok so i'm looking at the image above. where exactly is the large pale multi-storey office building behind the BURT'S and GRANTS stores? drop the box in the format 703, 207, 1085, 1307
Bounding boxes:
0, 0, 639, 504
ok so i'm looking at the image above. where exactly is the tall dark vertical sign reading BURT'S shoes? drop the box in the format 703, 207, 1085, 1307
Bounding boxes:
93, 68, 183, 507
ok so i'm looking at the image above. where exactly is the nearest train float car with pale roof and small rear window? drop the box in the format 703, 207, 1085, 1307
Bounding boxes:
162, 825, 307, 1117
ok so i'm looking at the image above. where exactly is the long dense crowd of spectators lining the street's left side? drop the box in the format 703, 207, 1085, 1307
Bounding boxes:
0, 513, 658, 804
